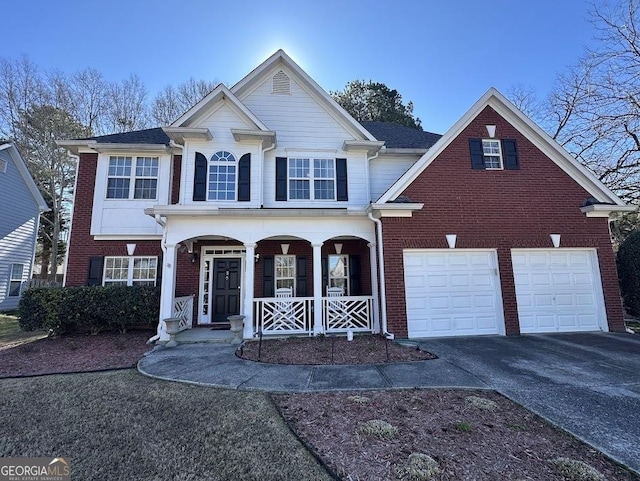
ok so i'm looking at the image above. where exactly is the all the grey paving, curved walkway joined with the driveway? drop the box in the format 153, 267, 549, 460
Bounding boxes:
138, 333, 640, 473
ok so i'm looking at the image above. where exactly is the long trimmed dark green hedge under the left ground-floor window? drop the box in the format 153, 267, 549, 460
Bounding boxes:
19, 286, 160, 334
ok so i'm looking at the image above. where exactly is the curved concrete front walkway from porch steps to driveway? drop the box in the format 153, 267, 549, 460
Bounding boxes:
138, 344, 488, 392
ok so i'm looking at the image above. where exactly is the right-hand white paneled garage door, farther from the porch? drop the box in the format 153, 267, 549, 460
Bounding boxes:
511, 249, 606, 333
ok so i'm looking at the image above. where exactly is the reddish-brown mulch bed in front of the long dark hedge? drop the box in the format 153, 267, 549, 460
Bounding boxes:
0, 331, 154, 378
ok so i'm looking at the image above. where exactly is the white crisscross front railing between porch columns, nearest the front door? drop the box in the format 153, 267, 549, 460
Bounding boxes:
253, 297, 313, 335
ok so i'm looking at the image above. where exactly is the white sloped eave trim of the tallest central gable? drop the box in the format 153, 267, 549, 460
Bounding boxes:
231, 49, 376, 141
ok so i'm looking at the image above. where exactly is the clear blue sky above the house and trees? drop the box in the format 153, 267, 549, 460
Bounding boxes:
0, 0, 604, 133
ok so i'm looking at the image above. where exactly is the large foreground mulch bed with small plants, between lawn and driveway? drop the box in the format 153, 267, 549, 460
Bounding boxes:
272, 390, 640, 481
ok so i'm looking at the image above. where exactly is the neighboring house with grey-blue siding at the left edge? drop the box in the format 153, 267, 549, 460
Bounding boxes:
0, 141, 49, 311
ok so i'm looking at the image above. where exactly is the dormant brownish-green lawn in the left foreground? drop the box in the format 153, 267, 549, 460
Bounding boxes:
0, 370, 331, 481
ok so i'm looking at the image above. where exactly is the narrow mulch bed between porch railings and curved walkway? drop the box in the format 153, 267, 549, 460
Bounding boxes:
238, 334, 436, 364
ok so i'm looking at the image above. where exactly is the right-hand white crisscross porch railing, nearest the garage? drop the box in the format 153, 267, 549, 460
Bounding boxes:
322, 296, 373, 334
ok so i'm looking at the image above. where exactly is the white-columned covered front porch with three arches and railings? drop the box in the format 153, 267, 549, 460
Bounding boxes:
151, 213, 380, 341
